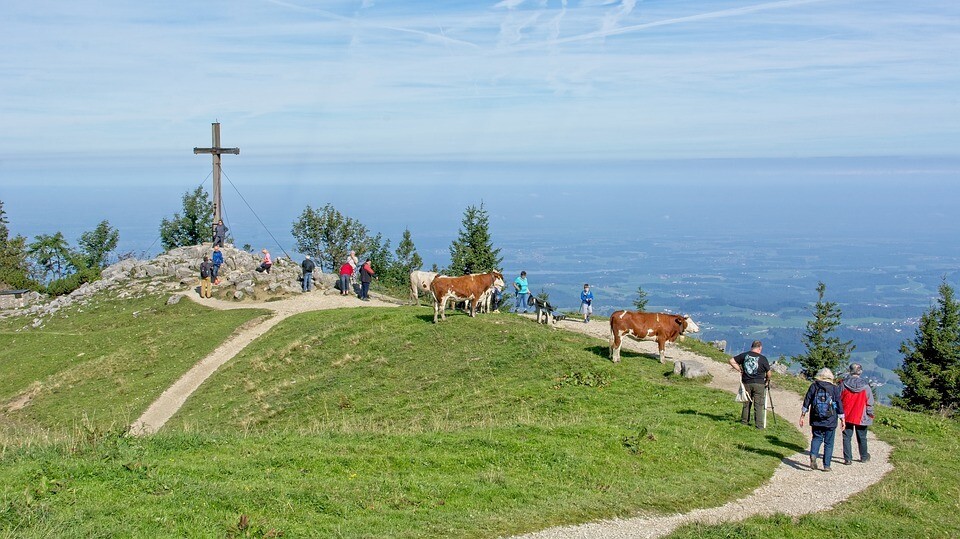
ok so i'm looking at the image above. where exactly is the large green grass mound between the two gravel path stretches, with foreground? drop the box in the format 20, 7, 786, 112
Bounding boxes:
0, 307, 804, 537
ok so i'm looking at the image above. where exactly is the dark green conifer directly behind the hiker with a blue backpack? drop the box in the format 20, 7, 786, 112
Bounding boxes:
791, 282, 856, 378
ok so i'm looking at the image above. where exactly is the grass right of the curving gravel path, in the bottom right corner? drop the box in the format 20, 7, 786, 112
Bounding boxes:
671, 407, 960, 539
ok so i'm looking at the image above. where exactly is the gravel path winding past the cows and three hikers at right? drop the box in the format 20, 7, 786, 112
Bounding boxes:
510, 320, 893, 539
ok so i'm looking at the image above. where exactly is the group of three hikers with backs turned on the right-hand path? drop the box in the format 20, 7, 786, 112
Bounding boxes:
729, 341, 874, 472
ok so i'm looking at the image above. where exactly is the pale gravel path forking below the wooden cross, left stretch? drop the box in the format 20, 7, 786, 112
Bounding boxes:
130, 291, 397, 436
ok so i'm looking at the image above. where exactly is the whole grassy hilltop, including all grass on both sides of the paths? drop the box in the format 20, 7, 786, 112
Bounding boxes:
0, 297, 960, 537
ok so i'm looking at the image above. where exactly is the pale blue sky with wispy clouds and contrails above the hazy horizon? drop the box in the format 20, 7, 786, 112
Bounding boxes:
0, 0, 960, 166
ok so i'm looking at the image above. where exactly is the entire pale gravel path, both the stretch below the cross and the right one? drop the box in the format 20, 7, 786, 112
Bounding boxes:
130, 298, 893, 539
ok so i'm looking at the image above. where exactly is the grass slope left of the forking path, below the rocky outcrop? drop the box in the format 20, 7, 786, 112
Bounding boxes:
0, 296, 266, 443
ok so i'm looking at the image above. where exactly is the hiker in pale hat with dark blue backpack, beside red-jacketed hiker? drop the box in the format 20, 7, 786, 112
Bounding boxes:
800, 369, 844, 472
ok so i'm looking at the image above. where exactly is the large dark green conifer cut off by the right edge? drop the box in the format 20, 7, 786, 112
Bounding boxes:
892, 281, 960, 414
